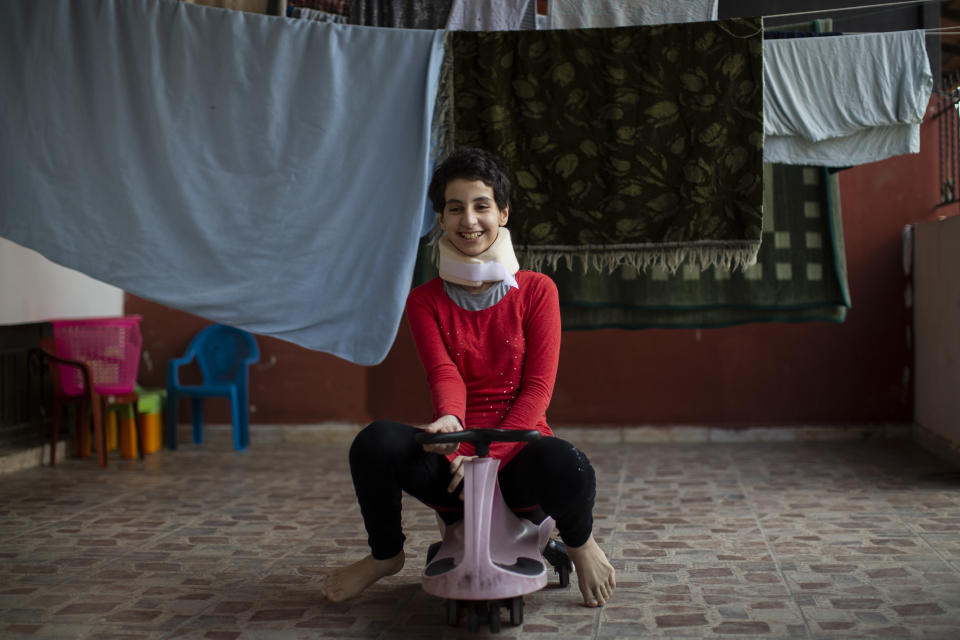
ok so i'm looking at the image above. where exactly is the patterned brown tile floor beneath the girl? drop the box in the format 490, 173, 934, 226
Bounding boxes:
0, 432, 960, 640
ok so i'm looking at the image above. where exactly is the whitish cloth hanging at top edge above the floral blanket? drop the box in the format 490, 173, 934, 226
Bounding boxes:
547, 0, 718, 29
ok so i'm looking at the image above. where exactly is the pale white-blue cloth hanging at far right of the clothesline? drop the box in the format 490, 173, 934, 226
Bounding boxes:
763, 30, 933, 167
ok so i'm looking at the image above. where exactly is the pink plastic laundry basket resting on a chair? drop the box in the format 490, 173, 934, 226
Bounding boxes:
51, 316, 142, 396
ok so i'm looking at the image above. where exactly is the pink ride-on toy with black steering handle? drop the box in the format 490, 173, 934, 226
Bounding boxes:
416, 429, 573, 633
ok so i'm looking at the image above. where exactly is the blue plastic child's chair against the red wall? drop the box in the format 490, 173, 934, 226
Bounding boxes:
167, 324, 260, 449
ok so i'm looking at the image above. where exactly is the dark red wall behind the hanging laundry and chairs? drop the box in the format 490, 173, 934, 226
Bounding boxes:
133, 110, 955, 426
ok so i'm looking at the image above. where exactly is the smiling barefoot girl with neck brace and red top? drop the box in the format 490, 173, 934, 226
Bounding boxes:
323, 148, 616, 607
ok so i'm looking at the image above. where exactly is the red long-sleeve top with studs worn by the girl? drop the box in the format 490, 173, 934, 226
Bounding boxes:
407, 271, 560, 467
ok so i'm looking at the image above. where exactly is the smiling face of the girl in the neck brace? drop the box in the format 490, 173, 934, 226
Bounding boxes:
440, 178, 510, 256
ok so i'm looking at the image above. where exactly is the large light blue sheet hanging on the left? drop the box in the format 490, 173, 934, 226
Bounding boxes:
0, 0, 443, 365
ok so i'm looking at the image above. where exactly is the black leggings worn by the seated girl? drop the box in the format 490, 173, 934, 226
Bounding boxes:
350, 420, 597, 560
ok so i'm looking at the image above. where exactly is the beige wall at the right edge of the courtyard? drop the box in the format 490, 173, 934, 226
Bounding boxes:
913, 215, 960, 451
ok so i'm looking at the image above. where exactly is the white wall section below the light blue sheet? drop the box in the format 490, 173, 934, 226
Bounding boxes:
0, 238, 123, 325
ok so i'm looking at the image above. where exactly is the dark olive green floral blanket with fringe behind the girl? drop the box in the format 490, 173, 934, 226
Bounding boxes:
446, 19, 763, 272
